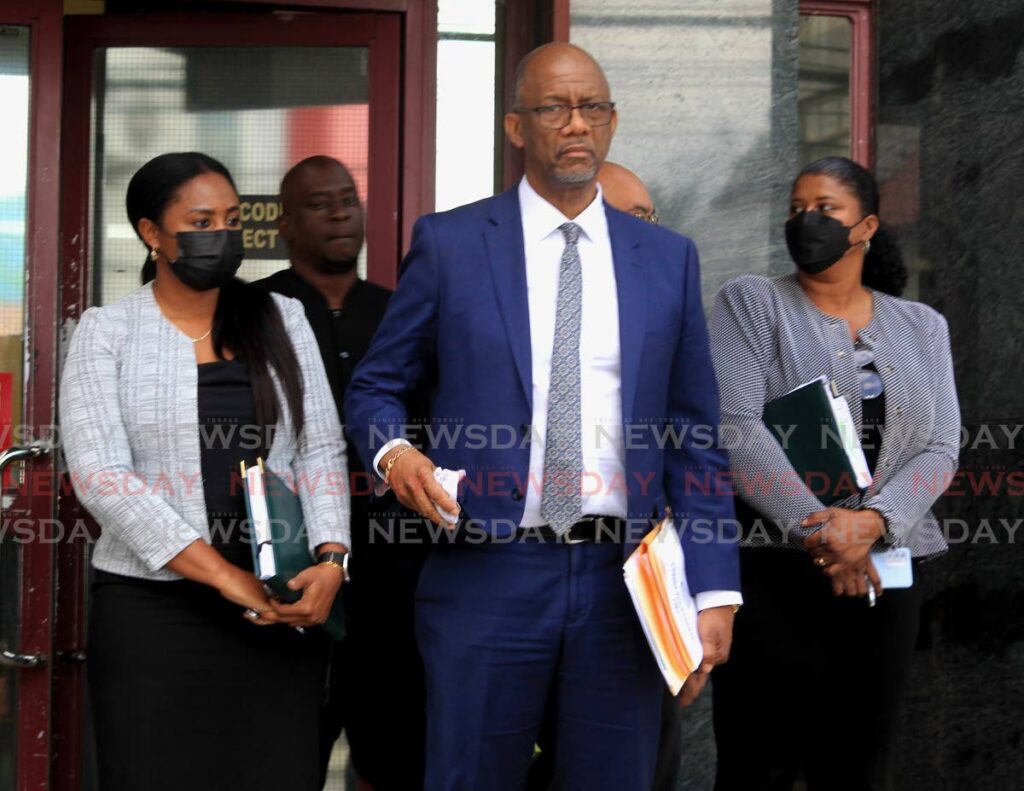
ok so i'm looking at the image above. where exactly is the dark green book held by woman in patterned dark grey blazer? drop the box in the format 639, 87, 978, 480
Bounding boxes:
763, 378, 867, 505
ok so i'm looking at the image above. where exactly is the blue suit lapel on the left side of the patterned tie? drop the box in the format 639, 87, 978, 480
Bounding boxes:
484, 188, 534, 409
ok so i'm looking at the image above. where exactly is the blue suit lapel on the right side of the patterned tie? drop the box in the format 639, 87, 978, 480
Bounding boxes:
605, 206, 647, 422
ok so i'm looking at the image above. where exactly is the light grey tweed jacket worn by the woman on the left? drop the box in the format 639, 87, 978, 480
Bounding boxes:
59, 286, 350, 580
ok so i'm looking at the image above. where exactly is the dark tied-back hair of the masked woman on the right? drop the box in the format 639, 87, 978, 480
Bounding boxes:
794, 157, 907, 296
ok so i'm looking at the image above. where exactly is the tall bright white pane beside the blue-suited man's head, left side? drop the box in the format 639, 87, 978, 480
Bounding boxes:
434, 39, 495, 211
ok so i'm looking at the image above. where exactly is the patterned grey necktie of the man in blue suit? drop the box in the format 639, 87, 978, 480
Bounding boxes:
541, 222, 583, 535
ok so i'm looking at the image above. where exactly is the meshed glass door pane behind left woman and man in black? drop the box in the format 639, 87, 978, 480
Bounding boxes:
93, 47, 370, 304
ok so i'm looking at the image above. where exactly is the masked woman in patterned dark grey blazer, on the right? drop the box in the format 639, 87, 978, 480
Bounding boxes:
711, 157, 959, 791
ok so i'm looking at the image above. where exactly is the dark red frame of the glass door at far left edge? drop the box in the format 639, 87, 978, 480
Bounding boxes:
0, 0, 62, 791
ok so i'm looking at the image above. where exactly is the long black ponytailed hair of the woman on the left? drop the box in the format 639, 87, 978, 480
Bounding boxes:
125, 152, 305, 435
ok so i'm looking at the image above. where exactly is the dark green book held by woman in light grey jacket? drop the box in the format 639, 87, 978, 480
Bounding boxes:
242, 459, 345, 640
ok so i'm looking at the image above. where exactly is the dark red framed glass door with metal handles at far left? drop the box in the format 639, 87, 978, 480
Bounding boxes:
0, 0, 59, 791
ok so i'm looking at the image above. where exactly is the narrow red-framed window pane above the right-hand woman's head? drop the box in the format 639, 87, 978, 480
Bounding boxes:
800, 14, 853, 165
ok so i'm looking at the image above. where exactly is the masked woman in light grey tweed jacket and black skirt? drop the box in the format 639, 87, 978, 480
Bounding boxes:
60, 154, 349, 791
